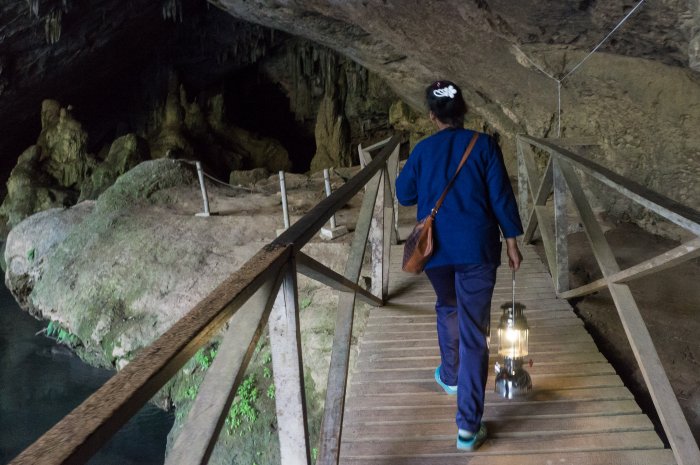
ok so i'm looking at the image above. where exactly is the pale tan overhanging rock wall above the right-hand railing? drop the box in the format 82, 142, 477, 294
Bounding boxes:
216, 0, 700, 237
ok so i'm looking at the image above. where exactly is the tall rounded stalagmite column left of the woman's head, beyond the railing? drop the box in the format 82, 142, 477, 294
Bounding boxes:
311, 93, 352, 173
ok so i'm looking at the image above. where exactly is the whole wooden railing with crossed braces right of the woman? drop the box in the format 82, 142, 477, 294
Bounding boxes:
517, 136, 700, 465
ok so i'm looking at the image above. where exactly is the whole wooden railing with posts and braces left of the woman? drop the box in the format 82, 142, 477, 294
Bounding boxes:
11, 136, 400, 465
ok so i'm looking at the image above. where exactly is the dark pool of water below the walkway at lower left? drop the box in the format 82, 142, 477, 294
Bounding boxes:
0, 284, 173, 465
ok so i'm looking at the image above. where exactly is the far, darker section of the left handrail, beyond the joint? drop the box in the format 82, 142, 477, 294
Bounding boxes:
272, 136, 401, 251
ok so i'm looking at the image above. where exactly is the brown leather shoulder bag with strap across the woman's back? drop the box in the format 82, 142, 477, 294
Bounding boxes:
401, 132, 479, 274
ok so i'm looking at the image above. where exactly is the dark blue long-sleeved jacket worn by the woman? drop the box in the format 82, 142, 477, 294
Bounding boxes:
396, 128, 523, 268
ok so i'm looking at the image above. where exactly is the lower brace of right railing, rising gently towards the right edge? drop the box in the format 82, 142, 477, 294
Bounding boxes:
558, 237, 700, 299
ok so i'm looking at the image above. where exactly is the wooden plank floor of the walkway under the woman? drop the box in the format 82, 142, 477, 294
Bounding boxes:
341, 246, 675, 465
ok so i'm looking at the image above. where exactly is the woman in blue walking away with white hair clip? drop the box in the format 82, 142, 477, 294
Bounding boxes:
396, 81, 523, 450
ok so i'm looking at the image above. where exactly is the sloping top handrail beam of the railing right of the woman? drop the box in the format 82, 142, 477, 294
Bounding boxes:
521, 136, 700, 236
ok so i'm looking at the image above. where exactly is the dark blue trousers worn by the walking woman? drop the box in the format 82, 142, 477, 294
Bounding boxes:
425, 265, 498, 432
